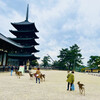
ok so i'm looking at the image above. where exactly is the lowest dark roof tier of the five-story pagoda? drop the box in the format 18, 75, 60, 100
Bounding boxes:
8, 53, 39, 60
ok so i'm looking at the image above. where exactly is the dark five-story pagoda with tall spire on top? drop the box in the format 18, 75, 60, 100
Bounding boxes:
8, 6, 39, 65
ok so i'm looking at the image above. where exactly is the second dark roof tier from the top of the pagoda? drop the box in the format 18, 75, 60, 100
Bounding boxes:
9, 30, 39, 39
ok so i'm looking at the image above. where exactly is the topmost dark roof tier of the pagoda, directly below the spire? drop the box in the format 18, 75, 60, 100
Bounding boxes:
11, 20, 39, 32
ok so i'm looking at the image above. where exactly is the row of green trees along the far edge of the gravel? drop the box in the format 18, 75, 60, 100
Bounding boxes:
31, 44, 100, 70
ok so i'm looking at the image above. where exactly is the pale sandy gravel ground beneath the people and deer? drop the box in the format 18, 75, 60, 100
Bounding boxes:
0, 70, 100, 100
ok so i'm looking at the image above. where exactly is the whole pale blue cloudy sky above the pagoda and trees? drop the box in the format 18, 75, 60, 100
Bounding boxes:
0, 0, 100, 65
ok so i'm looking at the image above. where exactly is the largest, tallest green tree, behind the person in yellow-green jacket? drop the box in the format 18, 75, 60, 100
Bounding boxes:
58, 44, 82, 70
